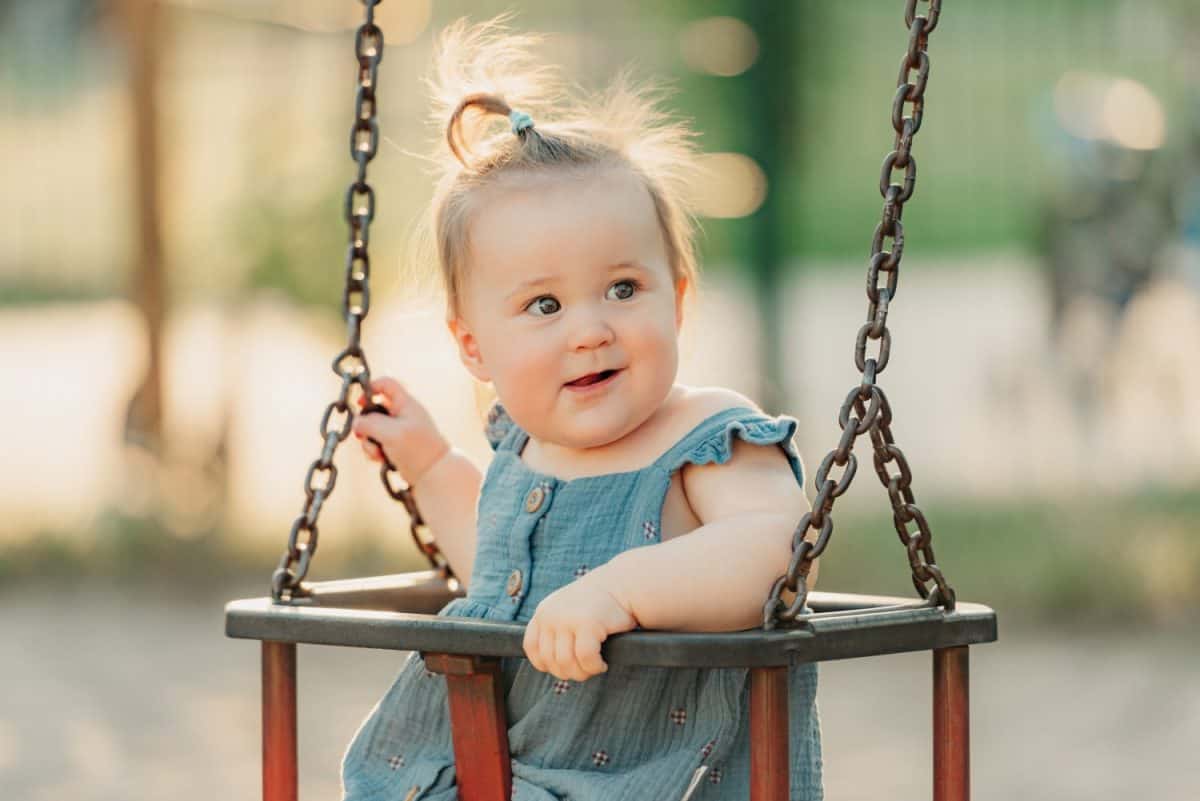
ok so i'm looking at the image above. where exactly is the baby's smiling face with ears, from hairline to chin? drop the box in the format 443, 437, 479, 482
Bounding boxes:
450, 167, 686, 448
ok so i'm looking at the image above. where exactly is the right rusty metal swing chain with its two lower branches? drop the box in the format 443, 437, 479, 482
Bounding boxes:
763, 0, 955, 630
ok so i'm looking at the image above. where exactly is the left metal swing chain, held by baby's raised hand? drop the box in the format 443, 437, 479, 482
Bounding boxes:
271, 0, 452, 602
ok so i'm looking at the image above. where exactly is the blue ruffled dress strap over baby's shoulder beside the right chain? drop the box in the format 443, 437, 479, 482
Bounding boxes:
659, 406, 804, 487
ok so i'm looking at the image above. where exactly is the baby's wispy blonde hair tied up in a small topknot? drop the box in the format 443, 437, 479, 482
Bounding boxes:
425, 14, 697, 314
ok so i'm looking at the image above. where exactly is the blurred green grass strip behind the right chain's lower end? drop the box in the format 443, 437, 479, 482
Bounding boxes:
820, 489, 1200, 622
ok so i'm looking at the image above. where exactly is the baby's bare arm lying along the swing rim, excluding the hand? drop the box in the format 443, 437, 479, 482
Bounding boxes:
590, 439, 817, 632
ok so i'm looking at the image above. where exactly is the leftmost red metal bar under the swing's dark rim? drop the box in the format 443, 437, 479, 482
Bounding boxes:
263, 640, 298, 801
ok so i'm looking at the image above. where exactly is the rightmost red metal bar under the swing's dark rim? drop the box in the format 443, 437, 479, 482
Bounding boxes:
934, 645, 971, 801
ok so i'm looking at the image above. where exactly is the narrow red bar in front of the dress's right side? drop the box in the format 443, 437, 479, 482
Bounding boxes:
750, 667, 790, 801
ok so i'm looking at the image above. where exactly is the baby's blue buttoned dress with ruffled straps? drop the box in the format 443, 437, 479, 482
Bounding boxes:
342, 404, 822, 801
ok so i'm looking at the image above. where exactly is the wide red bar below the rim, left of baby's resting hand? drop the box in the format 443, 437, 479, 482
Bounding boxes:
422, 654, 512, 801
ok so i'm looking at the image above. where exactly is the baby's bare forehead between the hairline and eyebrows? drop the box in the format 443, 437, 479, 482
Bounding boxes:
468, 165, 670, 283
